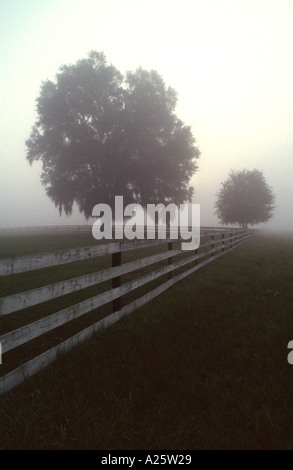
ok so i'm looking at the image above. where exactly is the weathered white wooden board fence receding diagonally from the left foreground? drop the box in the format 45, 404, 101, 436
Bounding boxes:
0, 228, 254, 394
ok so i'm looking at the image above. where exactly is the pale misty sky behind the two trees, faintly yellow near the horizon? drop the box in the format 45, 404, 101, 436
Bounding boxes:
0, 0, 293, 230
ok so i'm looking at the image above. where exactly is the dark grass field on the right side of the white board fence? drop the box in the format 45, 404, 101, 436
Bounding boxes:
0, 229, 293, 450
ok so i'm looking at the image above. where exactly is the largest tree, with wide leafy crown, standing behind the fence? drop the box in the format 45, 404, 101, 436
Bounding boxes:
26, 51, 200, 218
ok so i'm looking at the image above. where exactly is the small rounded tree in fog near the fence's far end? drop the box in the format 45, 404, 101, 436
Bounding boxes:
215, 170, 275, 228
